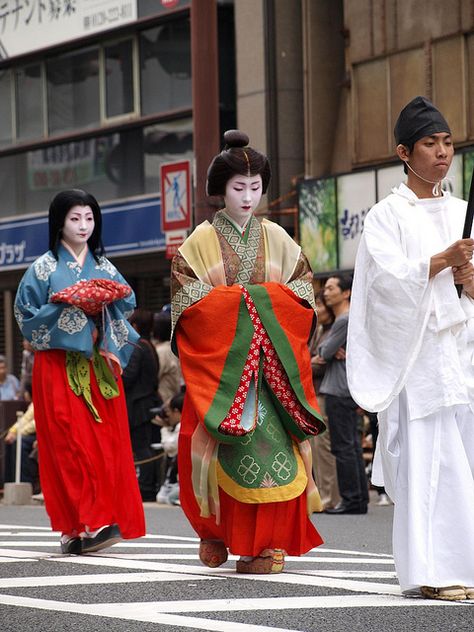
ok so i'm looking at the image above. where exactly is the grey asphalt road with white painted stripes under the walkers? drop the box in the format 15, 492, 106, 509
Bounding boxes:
0, 503, 474, 632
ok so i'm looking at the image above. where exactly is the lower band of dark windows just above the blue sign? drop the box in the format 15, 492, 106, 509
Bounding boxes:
0, 119, 192, 217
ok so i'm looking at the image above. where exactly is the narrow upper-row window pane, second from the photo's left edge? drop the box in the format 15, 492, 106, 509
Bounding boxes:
15, 64, 44, 140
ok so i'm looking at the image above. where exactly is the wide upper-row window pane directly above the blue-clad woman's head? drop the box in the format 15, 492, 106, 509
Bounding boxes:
46, 47, 100, 134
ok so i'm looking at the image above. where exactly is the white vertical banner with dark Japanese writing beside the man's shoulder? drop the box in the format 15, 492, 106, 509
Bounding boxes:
337, 171, 376, 270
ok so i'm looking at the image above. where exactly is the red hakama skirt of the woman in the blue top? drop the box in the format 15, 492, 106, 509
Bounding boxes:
33, 350, 145, 539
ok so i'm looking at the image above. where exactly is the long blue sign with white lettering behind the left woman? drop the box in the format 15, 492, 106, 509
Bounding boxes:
0, 196, 166, 271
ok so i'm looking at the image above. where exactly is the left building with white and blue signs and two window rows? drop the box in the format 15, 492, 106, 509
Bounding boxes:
0, 0, 235, 369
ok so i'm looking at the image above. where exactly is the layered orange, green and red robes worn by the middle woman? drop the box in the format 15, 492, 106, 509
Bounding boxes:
172, 212, 324, 556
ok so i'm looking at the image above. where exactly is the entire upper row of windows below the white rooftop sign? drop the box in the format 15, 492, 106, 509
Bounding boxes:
0, 14, 192, 149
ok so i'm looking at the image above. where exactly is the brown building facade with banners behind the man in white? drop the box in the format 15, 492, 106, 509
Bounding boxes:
235, 0, 474, 277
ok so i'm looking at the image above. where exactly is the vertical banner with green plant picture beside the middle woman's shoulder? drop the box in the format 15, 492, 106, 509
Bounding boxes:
298, 178, 337, 273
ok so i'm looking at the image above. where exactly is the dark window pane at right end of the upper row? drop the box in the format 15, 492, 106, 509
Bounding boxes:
139, 18, 191, 116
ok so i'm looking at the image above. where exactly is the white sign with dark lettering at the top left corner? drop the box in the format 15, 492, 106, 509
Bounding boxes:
0, 0, 137, 59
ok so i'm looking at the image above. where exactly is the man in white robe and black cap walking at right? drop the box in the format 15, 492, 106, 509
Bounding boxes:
347, 97, 474, 600
